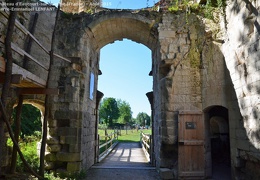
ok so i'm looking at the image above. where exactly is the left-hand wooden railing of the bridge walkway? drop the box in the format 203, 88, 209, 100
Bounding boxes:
97, 130, 118, 162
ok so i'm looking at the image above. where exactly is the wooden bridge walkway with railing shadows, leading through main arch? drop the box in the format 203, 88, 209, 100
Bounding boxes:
86, 143, 160, 180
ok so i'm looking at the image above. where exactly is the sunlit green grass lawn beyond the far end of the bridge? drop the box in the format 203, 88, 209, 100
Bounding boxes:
98, 129, 152, 142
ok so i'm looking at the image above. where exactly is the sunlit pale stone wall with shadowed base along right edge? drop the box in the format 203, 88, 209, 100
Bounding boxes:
222, 0, 260, 179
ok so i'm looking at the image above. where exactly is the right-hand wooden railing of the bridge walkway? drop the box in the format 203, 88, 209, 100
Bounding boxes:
140, 132, 152, 161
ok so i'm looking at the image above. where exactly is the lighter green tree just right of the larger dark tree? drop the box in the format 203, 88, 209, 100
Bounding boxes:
117, 99, 132, 124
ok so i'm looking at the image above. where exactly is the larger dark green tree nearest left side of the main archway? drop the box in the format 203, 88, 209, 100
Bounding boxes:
99, 97, 119, 126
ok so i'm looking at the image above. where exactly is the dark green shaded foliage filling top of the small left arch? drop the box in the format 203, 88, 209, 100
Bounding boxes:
12, 104, 42, 138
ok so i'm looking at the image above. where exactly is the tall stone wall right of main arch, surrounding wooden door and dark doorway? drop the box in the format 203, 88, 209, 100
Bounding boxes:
153, 9, 256, 177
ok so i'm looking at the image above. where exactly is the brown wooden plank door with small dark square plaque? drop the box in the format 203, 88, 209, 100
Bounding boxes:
178, 111, 205, 179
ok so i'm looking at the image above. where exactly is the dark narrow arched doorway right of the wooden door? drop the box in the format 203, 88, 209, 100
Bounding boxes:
204, 106, 231, 180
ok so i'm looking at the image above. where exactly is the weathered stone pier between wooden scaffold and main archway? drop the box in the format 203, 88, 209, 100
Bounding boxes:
43, 14, 99, 172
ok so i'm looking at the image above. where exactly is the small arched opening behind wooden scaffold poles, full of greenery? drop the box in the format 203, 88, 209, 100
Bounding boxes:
8, 101, 43, 172
